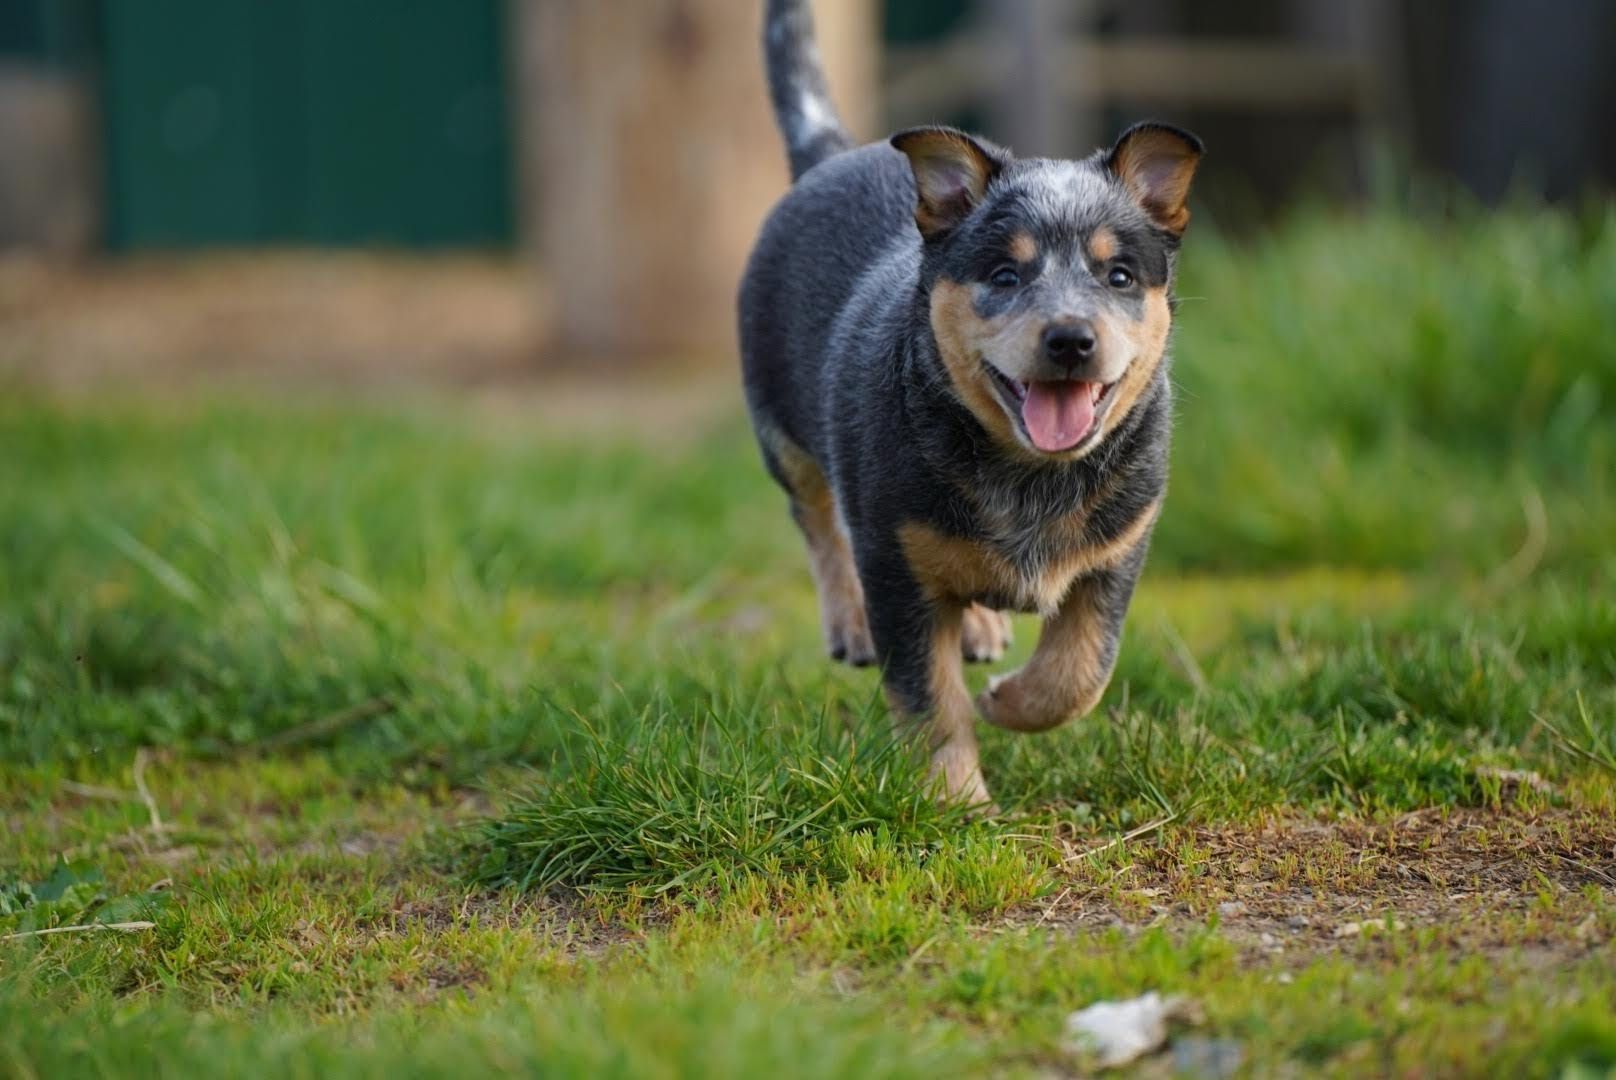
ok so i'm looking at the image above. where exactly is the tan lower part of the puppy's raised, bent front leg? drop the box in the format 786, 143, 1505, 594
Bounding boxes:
976, 579, 1112, 731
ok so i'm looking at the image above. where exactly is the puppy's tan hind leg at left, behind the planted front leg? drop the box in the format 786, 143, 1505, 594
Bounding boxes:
768, 432, 876, 666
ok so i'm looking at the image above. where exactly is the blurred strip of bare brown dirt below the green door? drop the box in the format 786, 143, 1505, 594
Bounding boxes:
0, 252, 543, 388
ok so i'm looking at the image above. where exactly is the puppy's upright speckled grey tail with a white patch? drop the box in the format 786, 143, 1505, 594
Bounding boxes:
763, 0, 853, 179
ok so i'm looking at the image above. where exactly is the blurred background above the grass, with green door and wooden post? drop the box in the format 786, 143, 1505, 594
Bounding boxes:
0, 0, 1616, 383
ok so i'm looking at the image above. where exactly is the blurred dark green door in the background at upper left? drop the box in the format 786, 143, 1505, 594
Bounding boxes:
102, 0, 512, 249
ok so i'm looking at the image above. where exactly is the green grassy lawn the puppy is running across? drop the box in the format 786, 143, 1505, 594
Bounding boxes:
0, 210, 1616, 1078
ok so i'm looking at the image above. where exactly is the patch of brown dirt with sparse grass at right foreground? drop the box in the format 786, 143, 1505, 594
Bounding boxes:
1012, 808, 1616, 959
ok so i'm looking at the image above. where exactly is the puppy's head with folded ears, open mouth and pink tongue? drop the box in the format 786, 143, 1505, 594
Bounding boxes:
892, 124, 1201, 461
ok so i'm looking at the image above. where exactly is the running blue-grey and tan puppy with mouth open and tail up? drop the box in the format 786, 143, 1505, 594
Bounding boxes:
740, 0, 1201, 805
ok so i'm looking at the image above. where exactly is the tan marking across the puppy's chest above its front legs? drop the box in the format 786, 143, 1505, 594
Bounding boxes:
898, 501, 1160, 616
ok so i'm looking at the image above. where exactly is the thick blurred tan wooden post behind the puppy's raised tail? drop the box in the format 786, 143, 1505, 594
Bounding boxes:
511, 0, 877, 362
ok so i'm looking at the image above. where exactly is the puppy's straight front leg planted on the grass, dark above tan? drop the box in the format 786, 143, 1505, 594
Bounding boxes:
861, 549, 992, 808
